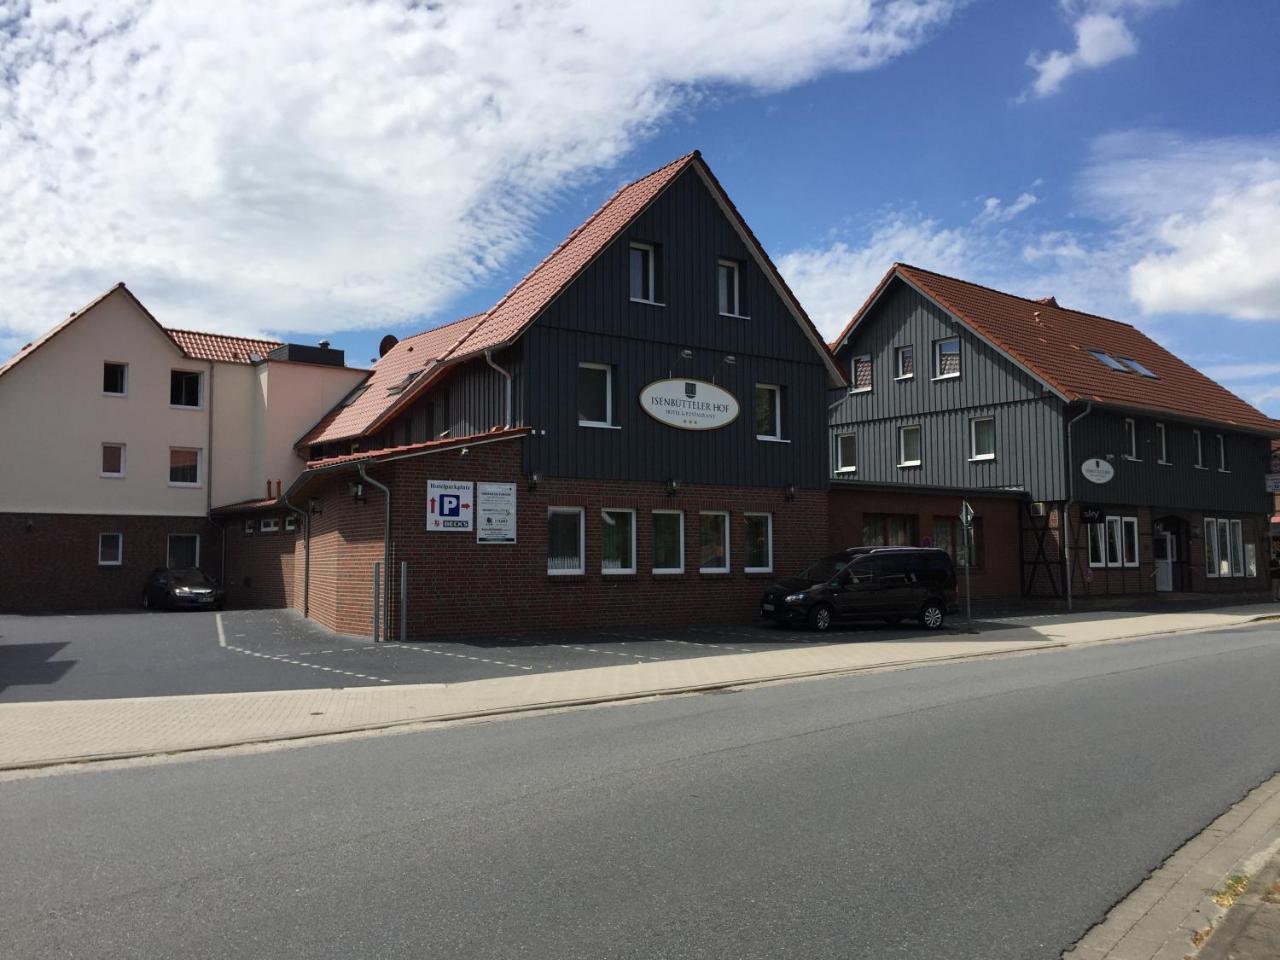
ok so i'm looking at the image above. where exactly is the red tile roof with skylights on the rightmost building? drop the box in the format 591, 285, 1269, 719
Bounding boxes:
832, 264, 1277, 435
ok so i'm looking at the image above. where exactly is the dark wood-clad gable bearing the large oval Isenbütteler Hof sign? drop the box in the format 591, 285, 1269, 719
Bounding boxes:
521, 170, 828, 488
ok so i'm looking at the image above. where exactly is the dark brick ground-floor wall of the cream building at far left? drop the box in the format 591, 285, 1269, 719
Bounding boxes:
0, 513, 221, 612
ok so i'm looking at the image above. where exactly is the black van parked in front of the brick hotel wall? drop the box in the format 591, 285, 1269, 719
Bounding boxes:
760, 547, 957, 630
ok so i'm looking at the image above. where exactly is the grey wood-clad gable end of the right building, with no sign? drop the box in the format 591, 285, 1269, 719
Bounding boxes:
828, 282, 1066, 500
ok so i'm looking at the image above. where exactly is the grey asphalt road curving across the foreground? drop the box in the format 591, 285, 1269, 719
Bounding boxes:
0, 625, 1280, 960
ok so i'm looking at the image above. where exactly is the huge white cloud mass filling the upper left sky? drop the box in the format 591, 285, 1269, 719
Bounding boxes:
0, 0, 957, 345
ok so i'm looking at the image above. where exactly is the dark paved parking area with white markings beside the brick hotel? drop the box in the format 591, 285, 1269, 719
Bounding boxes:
0, 611, 967, 703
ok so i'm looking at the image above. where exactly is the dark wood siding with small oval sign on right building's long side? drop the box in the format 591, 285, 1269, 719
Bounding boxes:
1071, 411, 1271, 513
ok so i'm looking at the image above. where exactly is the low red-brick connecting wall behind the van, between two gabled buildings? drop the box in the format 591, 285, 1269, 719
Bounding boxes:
827, 489, 1023, 599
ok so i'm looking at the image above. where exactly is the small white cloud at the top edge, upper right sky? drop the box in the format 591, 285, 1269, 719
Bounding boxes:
1021, 0, 1178, 100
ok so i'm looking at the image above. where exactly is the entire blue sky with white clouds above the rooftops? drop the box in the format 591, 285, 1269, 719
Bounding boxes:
0, 0, 1280, 416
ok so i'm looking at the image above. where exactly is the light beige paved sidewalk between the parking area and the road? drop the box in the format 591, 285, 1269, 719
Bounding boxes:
0, 604, 1280, 769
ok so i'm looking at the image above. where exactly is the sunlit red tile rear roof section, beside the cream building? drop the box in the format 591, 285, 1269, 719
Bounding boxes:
298, 314, 483, 445
